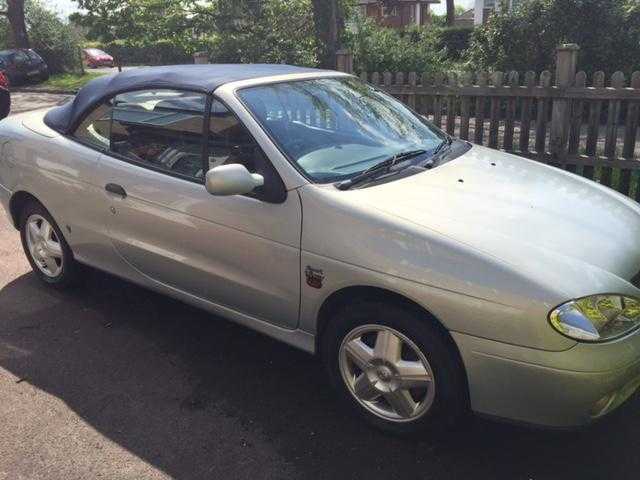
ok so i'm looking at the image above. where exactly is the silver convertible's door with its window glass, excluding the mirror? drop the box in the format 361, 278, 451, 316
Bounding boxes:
100, 90, 302, 328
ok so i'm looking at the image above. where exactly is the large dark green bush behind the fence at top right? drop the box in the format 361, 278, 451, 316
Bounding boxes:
467, 0, 640, 74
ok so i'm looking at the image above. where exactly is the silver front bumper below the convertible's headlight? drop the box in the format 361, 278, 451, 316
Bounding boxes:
451, 331, 640, 427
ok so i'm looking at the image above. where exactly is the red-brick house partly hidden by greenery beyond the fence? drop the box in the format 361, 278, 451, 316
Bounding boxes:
358, 0, 440, 28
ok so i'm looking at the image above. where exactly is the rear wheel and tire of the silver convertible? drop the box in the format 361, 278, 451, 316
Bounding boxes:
20, 201, 78, 288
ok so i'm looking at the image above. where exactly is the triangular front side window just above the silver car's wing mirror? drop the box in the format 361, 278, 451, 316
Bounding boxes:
208, 99, 286, 203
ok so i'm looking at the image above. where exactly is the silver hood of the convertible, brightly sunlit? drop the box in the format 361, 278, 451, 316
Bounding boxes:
353, 146, 640, 286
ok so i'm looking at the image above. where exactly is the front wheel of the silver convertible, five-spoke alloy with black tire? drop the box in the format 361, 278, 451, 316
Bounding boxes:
320, 301, 469, 436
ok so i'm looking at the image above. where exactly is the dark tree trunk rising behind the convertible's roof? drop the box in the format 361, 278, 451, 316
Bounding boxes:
311, 0, 343, 69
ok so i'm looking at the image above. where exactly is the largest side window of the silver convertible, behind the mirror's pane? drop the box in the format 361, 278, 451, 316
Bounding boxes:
110, 90, 206, 180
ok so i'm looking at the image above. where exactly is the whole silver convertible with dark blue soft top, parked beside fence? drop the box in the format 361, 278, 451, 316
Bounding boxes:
0, 65, 640, 434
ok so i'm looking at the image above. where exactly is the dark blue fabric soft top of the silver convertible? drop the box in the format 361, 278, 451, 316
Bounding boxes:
44, 64, 330, 134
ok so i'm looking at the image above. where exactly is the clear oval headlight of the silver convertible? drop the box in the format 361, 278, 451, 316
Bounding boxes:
549, 295, 640, 342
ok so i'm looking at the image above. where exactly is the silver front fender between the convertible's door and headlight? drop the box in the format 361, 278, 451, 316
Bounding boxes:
300, 185, 575, 351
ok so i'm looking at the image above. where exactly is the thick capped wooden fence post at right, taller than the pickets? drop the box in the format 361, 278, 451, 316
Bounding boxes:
549, 43, 580, 159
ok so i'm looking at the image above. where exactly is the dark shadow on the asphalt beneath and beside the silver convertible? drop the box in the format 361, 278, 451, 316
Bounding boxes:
0, 271, 640, 480
